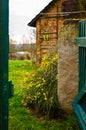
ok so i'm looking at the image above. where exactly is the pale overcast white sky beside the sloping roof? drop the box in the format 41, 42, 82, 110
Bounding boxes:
9, 0, 51, 43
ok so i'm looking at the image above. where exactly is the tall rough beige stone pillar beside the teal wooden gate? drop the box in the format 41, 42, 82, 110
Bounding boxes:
58, 23, 78, 112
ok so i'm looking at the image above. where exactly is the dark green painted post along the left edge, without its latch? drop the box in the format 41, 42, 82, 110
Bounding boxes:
0, 0, 9, 130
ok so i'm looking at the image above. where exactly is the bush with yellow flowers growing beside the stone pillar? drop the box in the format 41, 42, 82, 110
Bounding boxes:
23, 53, 58, 116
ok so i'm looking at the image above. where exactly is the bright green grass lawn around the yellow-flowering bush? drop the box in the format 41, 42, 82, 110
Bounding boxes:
9, 61, 78, 130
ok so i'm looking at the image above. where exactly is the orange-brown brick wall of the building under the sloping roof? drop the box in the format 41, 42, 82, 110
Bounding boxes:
36, 3, 58, 65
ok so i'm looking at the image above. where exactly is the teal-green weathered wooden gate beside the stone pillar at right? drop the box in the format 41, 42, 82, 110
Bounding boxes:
73, 20, 86, 130
